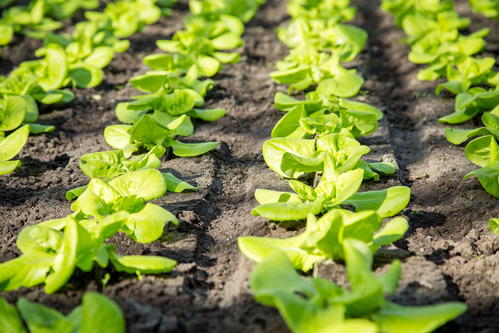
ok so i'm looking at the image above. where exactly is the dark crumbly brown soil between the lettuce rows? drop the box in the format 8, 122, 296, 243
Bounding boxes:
0, 0, 499, 332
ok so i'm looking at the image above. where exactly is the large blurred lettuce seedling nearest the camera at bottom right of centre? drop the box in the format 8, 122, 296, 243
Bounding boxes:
250, 238, 467, 333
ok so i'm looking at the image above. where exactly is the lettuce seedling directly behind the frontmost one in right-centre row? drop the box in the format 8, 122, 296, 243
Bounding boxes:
238, 209, 409, 272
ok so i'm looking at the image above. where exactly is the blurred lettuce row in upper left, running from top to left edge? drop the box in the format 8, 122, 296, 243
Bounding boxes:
0, 0, 178, 175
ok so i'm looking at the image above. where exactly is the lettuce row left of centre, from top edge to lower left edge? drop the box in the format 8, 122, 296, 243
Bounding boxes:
0, 1, 261, 332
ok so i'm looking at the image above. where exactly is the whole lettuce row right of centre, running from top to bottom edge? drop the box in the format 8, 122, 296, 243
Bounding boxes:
238, 0, 466, 333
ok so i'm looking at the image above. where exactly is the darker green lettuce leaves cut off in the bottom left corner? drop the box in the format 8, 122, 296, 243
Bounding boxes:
0, 292, 125, 333
